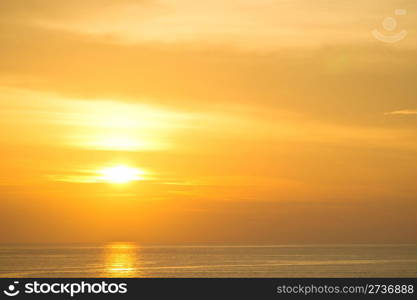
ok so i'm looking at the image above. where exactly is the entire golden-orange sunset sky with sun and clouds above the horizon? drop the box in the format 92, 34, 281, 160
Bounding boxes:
0, 0, 417, 244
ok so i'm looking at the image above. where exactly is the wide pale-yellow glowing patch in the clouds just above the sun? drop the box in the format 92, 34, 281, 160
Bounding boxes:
51, 95, 196, 152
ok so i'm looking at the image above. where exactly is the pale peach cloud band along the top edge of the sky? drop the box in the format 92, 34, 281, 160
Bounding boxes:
0, 0, 416, 51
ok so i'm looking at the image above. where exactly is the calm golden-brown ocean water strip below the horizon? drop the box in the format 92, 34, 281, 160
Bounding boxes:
0, 243, 417, 278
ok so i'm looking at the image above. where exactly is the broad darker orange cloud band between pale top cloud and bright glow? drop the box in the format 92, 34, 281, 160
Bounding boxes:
0, 20, 417, 125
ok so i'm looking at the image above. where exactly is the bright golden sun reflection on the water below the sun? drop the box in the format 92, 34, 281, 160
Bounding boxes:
104, 243, 141, 277
